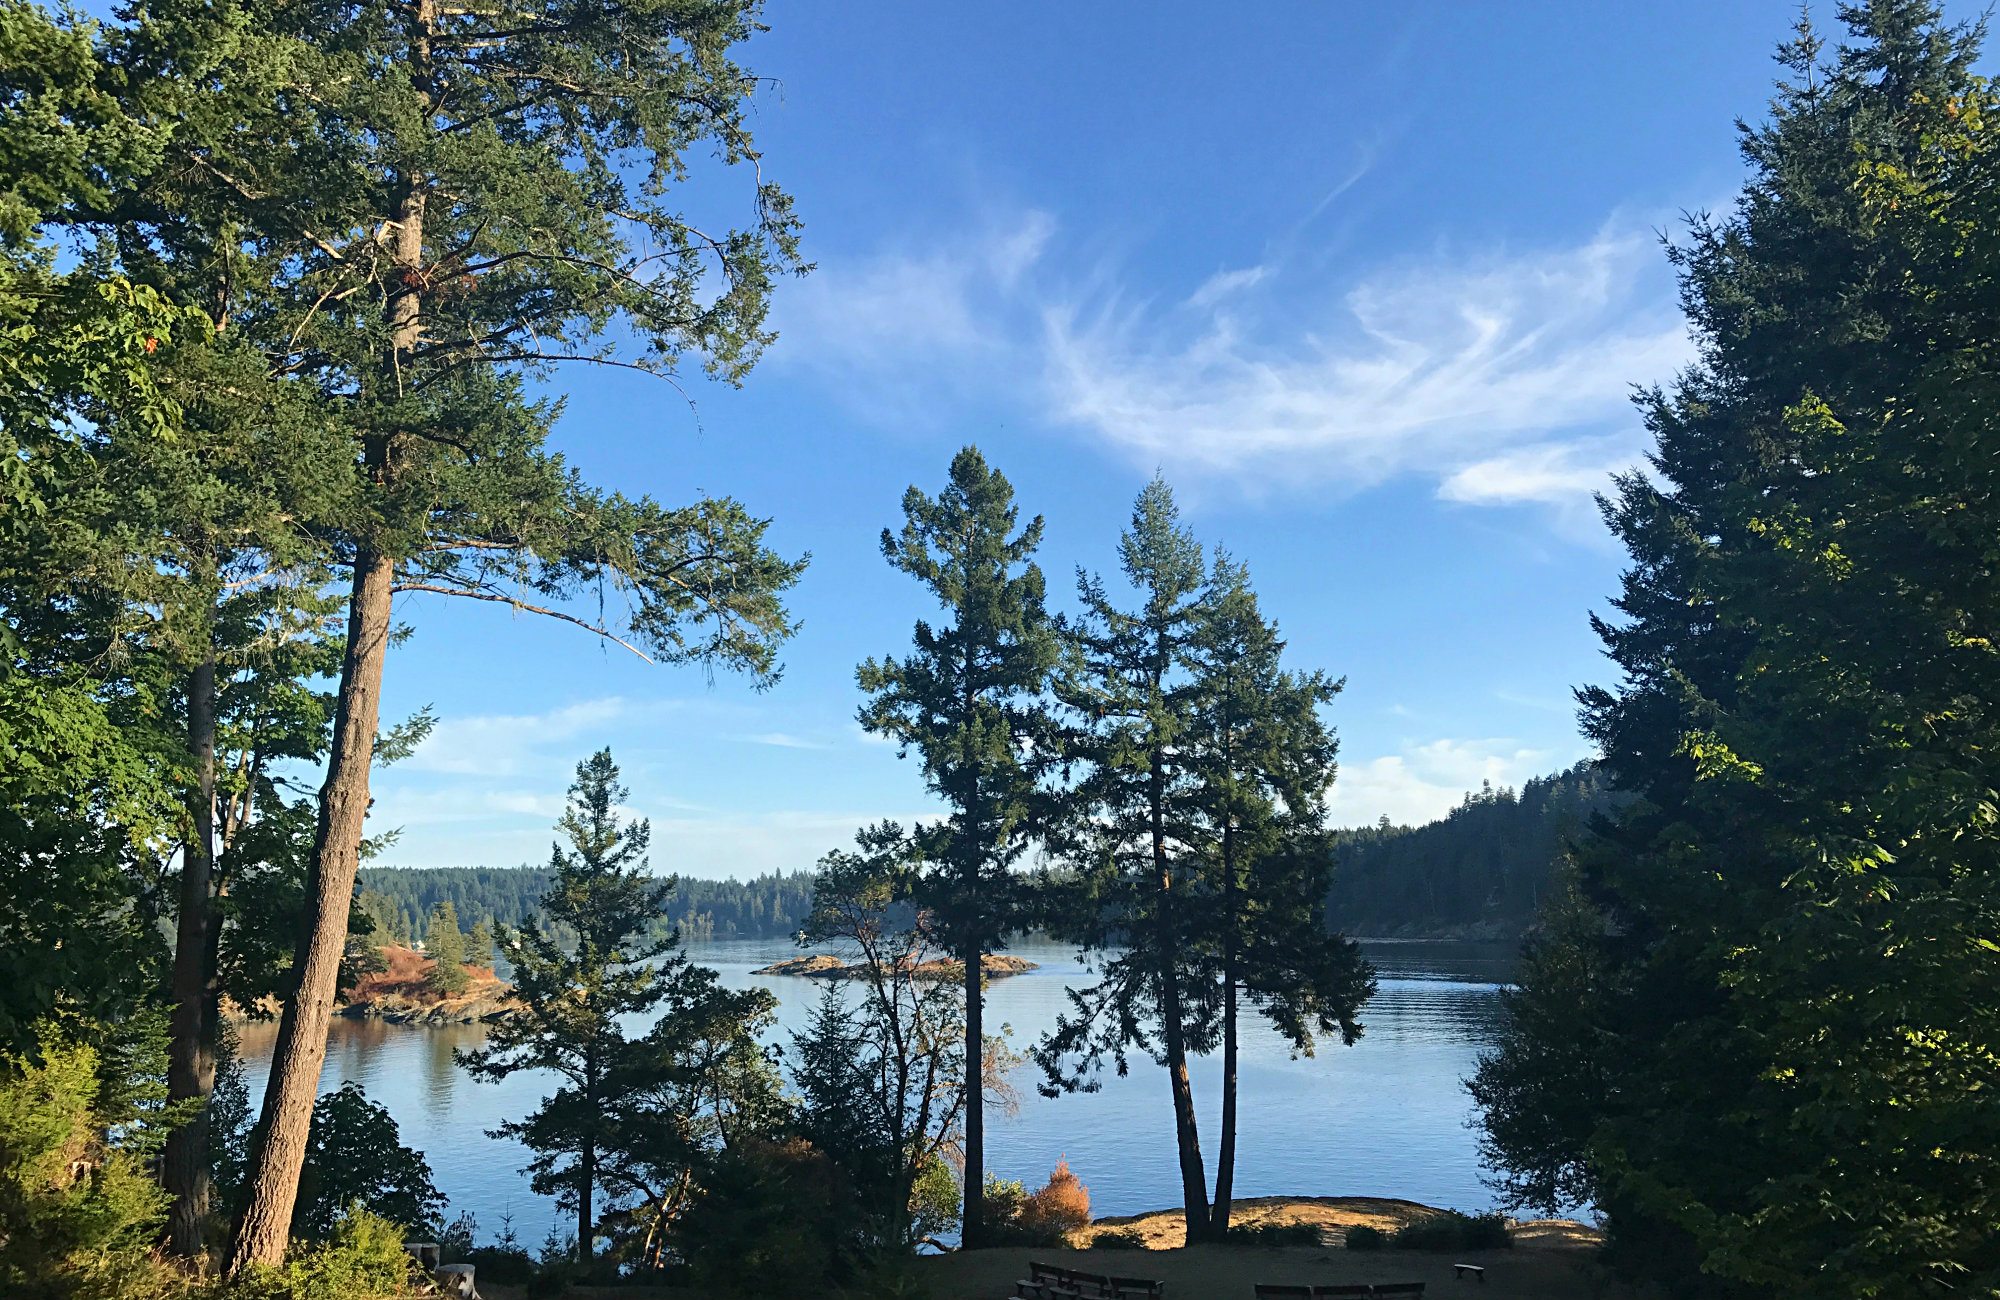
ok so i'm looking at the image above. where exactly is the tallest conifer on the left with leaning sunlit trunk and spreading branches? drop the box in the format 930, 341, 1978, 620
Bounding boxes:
74, 0, 800, 1272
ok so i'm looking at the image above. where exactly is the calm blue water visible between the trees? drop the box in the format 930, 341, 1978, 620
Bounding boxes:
242, 940, 1508, 1244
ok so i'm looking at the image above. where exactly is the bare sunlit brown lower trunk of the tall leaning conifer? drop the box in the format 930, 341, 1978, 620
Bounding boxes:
228, 548, 396, 1276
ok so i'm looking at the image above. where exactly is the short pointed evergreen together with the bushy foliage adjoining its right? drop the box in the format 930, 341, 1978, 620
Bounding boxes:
460, 750, 782, 1266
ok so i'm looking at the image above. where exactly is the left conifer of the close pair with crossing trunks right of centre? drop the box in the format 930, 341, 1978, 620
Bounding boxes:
1036, 478, 1222, 1242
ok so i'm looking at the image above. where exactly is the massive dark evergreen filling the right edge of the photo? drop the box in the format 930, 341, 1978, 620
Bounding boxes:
1482, 0, 2000, 1296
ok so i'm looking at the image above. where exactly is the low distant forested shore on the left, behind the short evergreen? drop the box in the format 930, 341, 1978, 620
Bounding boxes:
360, 866, 812, 942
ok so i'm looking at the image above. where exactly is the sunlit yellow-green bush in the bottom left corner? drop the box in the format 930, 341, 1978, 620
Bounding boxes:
0, 1036, 176, 1300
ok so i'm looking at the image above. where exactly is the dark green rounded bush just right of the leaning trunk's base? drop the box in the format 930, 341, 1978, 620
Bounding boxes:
292, 1082, 444, 1242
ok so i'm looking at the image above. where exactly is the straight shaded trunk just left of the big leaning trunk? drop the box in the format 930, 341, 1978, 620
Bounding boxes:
162, 640, 216, 1260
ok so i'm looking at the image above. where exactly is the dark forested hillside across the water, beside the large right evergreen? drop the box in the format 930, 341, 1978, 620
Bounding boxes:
1328, 762, 1610, 938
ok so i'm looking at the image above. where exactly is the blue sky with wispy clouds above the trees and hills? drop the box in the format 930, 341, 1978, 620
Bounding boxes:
370, 0, 1972, 876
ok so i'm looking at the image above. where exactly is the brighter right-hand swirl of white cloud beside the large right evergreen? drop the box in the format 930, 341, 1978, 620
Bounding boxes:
1044, 223, 1688, 492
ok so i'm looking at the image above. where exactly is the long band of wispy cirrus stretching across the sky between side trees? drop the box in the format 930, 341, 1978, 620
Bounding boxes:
786, 208, 1692, 512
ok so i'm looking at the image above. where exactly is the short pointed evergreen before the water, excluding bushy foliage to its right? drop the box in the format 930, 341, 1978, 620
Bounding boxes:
458, 750, 696, 1260
